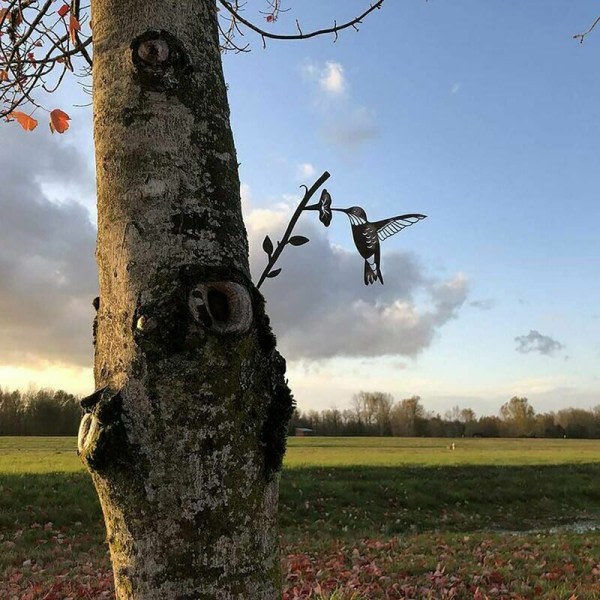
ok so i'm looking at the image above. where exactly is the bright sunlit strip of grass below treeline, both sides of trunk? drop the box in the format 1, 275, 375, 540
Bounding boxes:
0, 437, 600, 474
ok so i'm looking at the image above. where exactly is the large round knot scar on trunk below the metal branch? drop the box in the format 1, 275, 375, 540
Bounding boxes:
188, 281, 252, 333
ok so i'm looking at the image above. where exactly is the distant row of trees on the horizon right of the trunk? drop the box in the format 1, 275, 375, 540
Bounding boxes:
290, 392, 600, 438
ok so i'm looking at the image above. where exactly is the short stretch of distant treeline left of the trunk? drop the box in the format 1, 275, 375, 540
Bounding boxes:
0, 388, 81, 435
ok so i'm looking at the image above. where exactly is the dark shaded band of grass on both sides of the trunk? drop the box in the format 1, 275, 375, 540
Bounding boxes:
0, 464, 600, 539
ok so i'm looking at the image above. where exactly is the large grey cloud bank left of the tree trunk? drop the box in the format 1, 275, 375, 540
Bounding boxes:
0, 125, 97, 366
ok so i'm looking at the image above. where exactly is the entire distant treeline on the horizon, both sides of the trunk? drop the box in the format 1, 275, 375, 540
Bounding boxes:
0, 388, 600, 438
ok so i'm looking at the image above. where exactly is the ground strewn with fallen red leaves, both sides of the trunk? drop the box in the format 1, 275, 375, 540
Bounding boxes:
0, 523, 600, 600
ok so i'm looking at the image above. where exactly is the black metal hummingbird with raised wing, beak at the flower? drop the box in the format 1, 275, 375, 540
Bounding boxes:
331, 206, 427, 285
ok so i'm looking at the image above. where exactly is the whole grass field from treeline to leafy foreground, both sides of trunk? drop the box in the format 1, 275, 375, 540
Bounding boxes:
0, 437, 600, 600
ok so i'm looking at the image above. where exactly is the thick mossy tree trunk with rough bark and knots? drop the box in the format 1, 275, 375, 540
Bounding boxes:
79, 0, 293, 600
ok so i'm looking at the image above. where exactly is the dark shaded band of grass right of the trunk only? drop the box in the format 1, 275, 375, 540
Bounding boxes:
280, 463, 600, 538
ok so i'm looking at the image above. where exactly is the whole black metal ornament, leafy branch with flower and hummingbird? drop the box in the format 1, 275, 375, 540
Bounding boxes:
256, 171, 426, 288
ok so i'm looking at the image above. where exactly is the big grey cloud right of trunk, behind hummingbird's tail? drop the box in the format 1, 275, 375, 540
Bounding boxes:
248, 211, 467, 360
